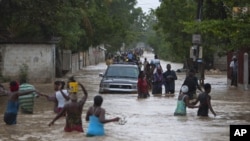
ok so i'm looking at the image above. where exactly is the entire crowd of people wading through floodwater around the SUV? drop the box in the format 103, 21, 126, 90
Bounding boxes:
0, 48, 216, 136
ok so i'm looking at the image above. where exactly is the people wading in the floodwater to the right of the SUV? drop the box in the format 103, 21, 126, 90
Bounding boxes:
137, 55, 216, 117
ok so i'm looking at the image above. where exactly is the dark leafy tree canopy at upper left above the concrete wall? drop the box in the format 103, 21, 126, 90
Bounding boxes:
0, 0, 146, 52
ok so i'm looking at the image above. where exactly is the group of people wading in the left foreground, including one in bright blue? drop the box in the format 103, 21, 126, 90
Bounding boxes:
0, 77, 120, 137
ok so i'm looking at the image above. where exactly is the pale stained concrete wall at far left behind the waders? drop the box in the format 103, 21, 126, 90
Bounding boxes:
0, 44, 55, 82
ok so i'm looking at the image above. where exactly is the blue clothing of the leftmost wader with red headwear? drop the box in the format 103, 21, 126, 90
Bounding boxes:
4, 100, 19, 125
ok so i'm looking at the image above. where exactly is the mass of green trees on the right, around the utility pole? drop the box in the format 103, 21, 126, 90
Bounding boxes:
151, 0, 250, 64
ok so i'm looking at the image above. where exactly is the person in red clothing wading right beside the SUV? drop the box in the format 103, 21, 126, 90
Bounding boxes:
137, 71, 149, 98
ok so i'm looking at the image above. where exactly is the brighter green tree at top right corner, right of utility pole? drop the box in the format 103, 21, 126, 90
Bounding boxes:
183, 0, 250, 55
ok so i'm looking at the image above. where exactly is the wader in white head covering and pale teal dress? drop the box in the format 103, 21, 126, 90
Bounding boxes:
174, 85, 198, 116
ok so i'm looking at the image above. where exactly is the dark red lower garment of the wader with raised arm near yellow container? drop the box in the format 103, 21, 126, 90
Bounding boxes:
64, 113, 83, 132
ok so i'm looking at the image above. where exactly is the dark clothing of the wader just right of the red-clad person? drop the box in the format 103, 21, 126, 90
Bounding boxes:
152, 73, 163, 94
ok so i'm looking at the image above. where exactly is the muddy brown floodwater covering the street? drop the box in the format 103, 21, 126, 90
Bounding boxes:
0, 54, 250, 141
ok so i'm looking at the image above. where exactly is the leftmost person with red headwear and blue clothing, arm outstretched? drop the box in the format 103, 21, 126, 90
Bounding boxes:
0, 81, 36, 125
